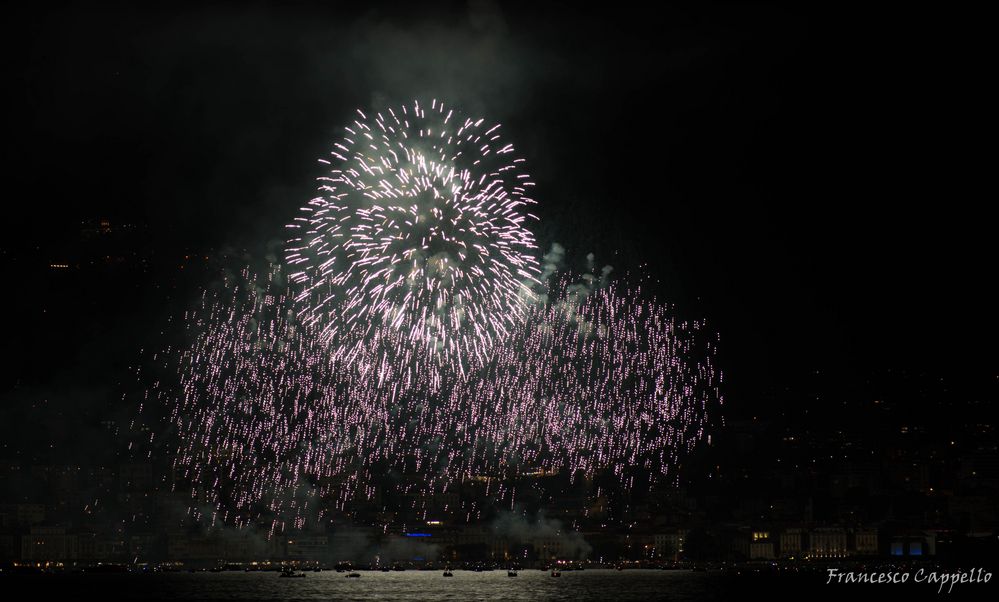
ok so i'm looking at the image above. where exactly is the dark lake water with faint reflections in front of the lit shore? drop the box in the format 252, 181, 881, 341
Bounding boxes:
0, 569, 976, 602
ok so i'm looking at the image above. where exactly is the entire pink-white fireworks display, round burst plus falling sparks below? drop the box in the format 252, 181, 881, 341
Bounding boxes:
142, 99, 722, 529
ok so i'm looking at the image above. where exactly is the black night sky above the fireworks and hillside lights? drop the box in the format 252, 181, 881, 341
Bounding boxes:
3, 2, 996, 428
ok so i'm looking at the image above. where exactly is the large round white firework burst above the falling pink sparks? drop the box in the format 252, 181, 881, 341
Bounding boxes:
286, 99, 540, 371
